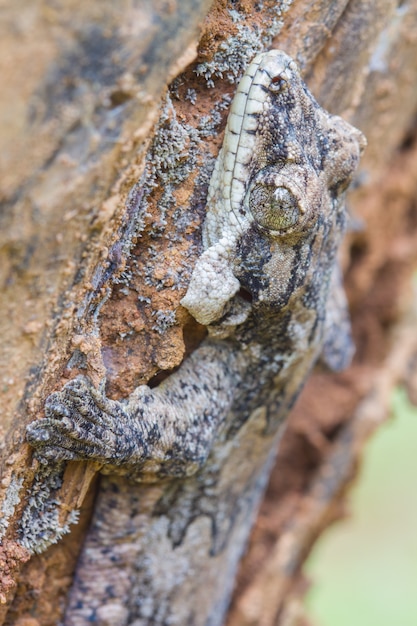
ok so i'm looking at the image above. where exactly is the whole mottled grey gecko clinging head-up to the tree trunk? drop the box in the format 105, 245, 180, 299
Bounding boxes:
28, 51, 364, 626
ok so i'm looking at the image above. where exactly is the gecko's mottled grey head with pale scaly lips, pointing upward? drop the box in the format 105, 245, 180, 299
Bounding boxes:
197, 50, 365, 324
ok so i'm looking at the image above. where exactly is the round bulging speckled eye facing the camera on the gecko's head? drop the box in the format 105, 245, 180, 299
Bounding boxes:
249, 185, 301, 232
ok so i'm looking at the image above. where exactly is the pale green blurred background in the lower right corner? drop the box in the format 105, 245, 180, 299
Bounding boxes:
305, 389, 417, 626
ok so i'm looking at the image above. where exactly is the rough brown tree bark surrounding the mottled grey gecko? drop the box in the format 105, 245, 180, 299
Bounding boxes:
0, 0, 417, 626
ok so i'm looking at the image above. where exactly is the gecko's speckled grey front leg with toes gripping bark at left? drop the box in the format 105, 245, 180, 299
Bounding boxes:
27, 342, 237, 479
